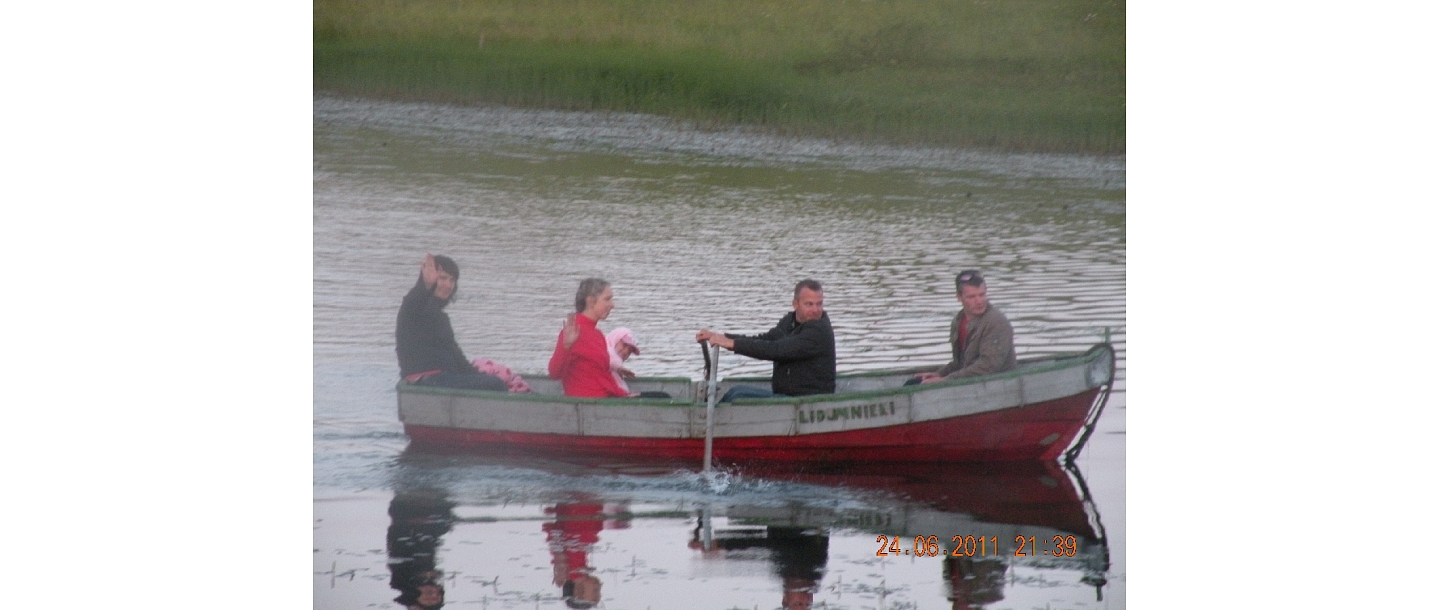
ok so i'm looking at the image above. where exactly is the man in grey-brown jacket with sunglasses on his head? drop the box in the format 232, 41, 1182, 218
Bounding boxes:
907, 269, 1015, 386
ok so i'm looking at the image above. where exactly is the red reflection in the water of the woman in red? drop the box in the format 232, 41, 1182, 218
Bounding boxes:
541, 501, 629, 609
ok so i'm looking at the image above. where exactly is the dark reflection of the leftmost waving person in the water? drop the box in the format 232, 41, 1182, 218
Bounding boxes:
386, 491, 455, 610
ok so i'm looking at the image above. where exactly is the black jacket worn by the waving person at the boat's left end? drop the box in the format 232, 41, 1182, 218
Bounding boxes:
395, 279, 475, 377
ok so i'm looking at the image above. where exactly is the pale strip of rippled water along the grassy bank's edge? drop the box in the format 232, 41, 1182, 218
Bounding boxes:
312, 92, 1126, 184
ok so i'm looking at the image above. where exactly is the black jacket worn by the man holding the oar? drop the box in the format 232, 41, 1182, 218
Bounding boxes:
726, 311, 835, 396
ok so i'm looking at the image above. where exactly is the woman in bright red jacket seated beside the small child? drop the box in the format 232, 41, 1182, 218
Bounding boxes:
550, 278, 636, 399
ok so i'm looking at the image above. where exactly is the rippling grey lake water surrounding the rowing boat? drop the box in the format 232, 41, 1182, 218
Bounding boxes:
314, 96, 1126, 610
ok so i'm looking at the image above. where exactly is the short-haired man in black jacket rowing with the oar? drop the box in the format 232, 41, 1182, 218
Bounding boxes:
696, 279, 835, 403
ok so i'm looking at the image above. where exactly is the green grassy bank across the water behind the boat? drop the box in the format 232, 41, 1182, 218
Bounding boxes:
314, 0, 1125, 153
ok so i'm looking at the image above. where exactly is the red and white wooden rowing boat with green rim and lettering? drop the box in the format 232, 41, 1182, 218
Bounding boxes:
396, 344, 1115, 463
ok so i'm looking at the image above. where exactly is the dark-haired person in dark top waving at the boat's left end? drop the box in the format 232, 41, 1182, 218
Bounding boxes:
395, 255, 508, 391
